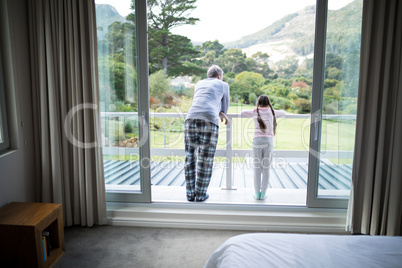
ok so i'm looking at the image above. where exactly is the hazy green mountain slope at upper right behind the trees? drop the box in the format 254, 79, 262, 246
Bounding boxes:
224, 0, 363, 62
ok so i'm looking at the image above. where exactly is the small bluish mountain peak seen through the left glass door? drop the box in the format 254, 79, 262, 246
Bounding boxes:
95, 4, 126, 39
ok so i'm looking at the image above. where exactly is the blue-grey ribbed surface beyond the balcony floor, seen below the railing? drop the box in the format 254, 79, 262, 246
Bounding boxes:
104, 160, 352, 190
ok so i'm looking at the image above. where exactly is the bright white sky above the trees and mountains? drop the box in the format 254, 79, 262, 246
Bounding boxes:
95, 0, 353, 43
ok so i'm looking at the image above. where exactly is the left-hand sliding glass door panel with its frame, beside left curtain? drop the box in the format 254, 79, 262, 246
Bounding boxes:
95, 0, 151, 202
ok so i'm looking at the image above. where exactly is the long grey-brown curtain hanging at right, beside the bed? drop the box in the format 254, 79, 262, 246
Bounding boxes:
349, 0, 402, 236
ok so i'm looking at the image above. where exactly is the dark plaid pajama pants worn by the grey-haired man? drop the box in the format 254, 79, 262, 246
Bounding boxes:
184, 119, 219, 199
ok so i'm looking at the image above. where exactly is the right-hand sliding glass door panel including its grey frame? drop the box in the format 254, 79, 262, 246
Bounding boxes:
307, 0, 363, 208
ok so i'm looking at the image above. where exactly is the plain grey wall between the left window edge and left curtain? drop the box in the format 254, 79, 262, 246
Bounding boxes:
0, 0, 38, 207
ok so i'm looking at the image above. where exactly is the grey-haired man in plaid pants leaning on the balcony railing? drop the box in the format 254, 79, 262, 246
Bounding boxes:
184, 65, 229, 202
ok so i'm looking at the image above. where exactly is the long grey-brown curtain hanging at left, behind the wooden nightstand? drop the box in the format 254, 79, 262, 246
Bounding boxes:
28, 0, 106, 226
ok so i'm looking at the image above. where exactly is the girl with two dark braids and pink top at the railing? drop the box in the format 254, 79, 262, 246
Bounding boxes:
241, 95, 285, 200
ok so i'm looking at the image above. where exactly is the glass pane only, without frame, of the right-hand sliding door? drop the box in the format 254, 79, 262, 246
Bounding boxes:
318, 0, 363, 198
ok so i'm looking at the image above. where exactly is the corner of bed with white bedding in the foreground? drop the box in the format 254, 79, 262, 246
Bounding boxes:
204, 233, 402, 268
